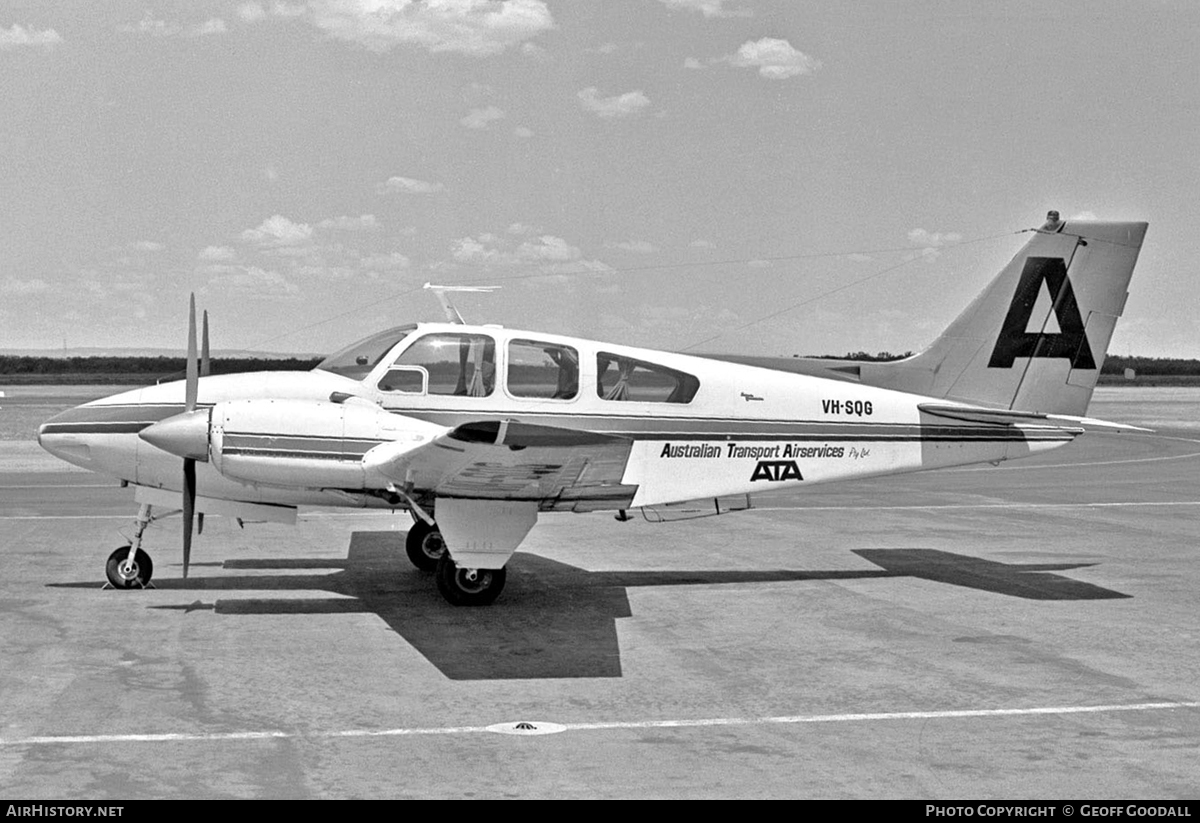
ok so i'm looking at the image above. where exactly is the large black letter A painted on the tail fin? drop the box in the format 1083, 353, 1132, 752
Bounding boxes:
988, 257, 1096, 368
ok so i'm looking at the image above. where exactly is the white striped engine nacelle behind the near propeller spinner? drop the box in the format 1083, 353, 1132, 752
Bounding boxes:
209, 400, 446, 489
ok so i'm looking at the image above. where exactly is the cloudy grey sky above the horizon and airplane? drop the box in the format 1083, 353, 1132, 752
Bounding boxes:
0, 0, 1200, 358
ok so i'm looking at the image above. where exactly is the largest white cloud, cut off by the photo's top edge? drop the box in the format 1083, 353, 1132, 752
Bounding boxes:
307, 0, 554, 56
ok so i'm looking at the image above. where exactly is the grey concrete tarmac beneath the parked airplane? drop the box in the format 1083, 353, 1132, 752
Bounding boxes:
0, 393, 1200, 801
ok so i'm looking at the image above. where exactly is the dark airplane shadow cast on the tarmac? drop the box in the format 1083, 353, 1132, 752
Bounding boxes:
49, 531, 1129, 680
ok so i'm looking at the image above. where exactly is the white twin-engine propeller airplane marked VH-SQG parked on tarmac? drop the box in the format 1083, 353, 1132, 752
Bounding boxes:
38, 211, 1147, 606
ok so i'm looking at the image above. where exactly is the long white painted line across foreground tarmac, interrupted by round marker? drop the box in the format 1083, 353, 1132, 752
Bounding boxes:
0, 701, 1200, 749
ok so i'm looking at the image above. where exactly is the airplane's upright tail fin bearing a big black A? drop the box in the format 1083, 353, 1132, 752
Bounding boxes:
859, 212, 1147, 415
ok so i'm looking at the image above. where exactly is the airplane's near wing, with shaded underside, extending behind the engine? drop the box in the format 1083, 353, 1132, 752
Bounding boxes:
364, 420, 637, 511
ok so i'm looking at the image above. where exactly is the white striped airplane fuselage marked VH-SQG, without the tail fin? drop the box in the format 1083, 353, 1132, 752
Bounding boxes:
40, 324, 1076, 511
